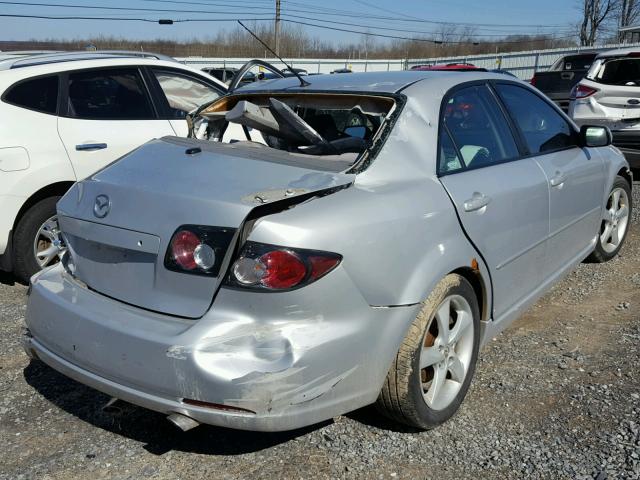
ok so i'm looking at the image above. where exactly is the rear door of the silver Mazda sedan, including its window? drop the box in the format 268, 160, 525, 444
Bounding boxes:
439, 83, 549, 320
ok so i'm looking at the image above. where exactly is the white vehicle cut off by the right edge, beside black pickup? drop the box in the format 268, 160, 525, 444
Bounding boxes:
569, 47, 640, 168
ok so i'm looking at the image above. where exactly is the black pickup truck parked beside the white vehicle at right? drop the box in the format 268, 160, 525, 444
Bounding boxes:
531, 52, 598, 112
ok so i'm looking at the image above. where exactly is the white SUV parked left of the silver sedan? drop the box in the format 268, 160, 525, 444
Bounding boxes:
0, 52, 227, 281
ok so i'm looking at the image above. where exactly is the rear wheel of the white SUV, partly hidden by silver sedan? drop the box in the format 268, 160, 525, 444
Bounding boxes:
13, 197, 60, 283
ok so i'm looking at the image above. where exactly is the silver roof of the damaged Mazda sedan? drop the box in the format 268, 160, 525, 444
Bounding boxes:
236, 70, 520, 94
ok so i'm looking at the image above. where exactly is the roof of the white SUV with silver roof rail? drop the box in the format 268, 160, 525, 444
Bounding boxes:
0, 50, 176, 70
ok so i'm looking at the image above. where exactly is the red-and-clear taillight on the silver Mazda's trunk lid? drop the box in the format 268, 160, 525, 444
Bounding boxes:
164, 225, 235, 276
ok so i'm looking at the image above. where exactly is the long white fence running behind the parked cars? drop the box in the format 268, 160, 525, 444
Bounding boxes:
177, 43, 640, 79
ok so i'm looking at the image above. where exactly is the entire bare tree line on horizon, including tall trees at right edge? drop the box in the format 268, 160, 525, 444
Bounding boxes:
5, 0, 640, 59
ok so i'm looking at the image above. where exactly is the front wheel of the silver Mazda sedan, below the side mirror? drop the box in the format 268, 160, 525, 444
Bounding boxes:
586, 176, 633, 263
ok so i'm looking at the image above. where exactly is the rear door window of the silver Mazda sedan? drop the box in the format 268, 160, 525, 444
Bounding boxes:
440, 85, 519, 173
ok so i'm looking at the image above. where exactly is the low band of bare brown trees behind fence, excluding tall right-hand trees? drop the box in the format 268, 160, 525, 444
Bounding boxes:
0, 24, 575, 60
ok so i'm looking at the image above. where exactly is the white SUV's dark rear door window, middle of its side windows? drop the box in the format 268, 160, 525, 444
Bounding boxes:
69, 69, 155, 120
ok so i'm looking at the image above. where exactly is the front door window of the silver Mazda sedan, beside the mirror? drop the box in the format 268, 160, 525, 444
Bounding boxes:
496, 84, 577, 154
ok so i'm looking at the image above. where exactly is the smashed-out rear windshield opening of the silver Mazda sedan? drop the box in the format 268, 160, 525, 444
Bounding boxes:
190, 94, 395, 164
